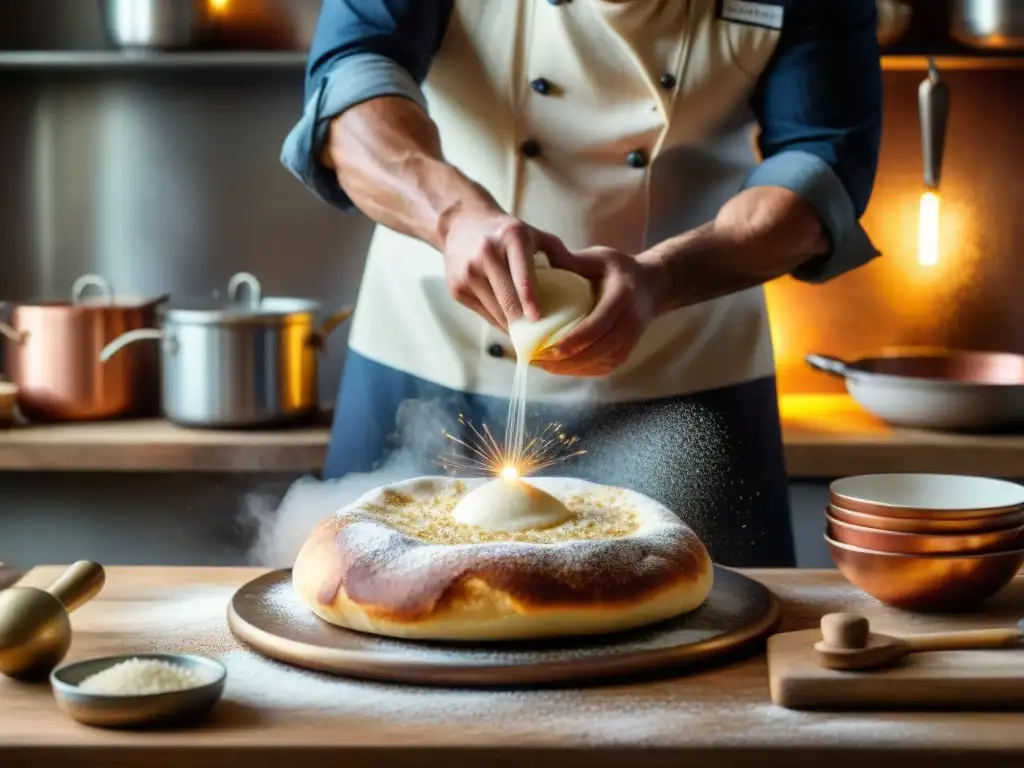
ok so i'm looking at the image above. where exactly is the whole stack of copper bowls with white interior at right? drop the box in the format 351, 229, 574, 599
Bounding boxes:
825, 474, 1024, 611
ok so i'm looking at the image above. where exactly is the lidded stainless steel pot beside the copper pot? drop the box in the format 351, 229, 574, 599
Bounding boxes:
99, 272, 352, 428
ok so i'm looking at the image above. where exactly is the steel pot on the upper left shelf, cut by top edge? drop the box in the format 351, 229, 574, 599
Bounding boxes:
99, 0, 213, 49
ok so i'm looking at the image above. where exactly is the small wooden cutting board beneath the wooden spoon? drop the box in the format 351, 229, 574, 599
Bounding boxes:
768, 629, 1024, 710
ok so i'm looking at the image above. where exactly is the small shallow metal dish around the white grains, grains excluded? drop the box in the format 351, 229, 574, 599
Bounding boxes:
50, 653, 227, 728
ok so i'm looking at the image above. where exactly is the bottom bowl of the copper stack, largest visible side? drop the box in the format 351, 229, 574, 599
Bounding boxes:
824, 535, 1024, 612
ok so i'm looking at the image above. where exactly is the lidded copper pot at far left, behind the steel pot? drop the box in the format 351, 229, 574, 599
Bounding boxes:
0, 274, 165, 421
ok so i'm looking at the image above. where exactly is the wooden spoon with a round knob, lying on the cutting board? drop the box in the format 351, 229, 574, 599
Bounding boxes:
814, 613, 1024, 670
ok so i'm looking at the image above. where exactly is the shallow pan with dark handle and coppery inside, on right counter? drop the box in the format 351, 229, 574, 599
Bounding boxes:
807, 348, 1024, 431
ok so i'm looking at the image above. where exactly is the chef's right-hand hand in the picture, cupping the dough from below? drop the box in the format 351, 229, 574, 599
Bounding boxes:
536, 248, 657, 376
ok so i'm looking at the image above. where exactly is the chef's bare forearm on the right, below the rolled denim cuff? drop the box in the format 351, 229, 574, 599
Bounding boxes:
638, 186, 828, 314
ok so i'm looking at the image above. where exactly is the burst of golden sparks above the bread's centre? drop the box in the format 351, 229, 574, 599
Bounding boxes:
437, 414, 587, 479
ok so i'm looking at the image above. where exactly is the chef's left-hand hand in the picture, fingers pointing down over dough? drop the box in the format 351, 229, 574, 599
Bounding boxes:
444, 209, 571, 331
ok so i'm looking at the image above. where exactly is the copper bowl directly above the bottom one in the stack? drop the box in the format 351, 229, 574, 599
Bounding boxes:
825, 510, 1024, 555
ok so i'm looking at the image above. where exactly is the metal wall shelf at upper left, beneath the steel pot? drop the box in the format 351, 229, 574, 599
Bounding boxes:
0, 50, 306, 71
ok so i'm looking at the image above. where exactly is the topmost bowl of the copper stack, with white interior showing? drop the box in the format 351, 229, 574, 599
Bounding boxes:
828, 472, 1024, 520
